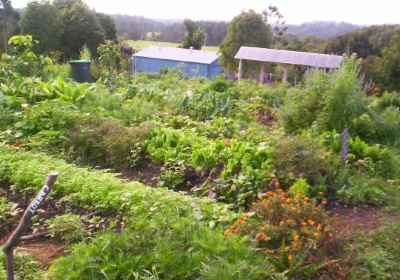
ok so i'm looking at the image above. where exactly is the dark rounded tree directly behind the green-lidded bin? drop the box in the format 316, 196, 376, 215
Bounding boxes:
58, 0, 105, 58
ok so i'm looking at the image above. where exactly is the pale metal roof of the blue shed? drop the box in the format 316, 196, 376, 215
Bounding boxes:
133, 46, 220, 64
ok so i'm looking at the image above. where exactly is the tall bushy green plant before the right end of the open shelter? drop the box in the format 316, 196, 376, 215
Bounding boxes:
278, 58, 366, 132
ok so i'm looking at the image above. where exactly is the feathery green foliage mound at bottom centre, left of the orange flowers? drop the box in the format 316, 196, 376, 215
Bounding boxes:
48, 220, 263, 279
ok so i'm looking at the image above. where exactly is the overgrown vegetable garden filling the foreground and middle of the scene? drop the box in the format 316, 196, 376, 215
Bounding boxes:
0, 37, 400, 279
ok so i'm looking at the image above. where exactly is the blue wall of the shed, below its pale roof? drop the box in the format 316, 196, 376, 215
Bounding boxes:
132, 56, 221, 78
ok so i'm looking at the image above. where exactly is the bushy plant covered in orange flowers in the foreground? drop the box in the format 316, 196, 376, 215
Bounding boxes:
224, 189, 334, 279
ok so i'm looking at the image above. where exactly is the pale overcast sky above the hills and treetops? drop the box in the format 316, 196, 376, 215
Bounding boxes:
11, 0, 400, 25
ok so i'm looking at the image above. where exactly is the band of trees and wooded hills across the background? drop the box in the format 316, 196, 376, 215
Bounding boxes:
0, 0, 400, 92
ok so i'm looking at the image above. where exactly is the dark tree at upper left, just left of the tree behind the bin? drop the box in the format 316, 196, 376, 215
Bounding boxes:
20, 1, 64, 53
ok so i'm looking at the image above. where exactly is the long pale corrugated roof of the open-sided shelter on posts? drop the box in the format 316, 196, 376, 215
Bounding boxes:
235, 47, 343, 68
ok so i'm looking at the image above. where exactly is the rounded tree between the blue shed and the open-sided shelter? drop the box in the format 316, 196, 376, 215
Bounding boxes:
220, 10, 272, 74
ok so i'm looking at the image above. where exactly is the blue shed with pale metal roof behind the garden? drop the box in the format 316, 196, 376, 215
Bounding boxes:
132, 46, 222, 79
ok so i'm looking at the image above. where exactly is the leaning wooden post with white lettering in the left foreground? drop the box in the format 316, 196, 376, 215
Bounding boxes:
3, 172, 58, 280
